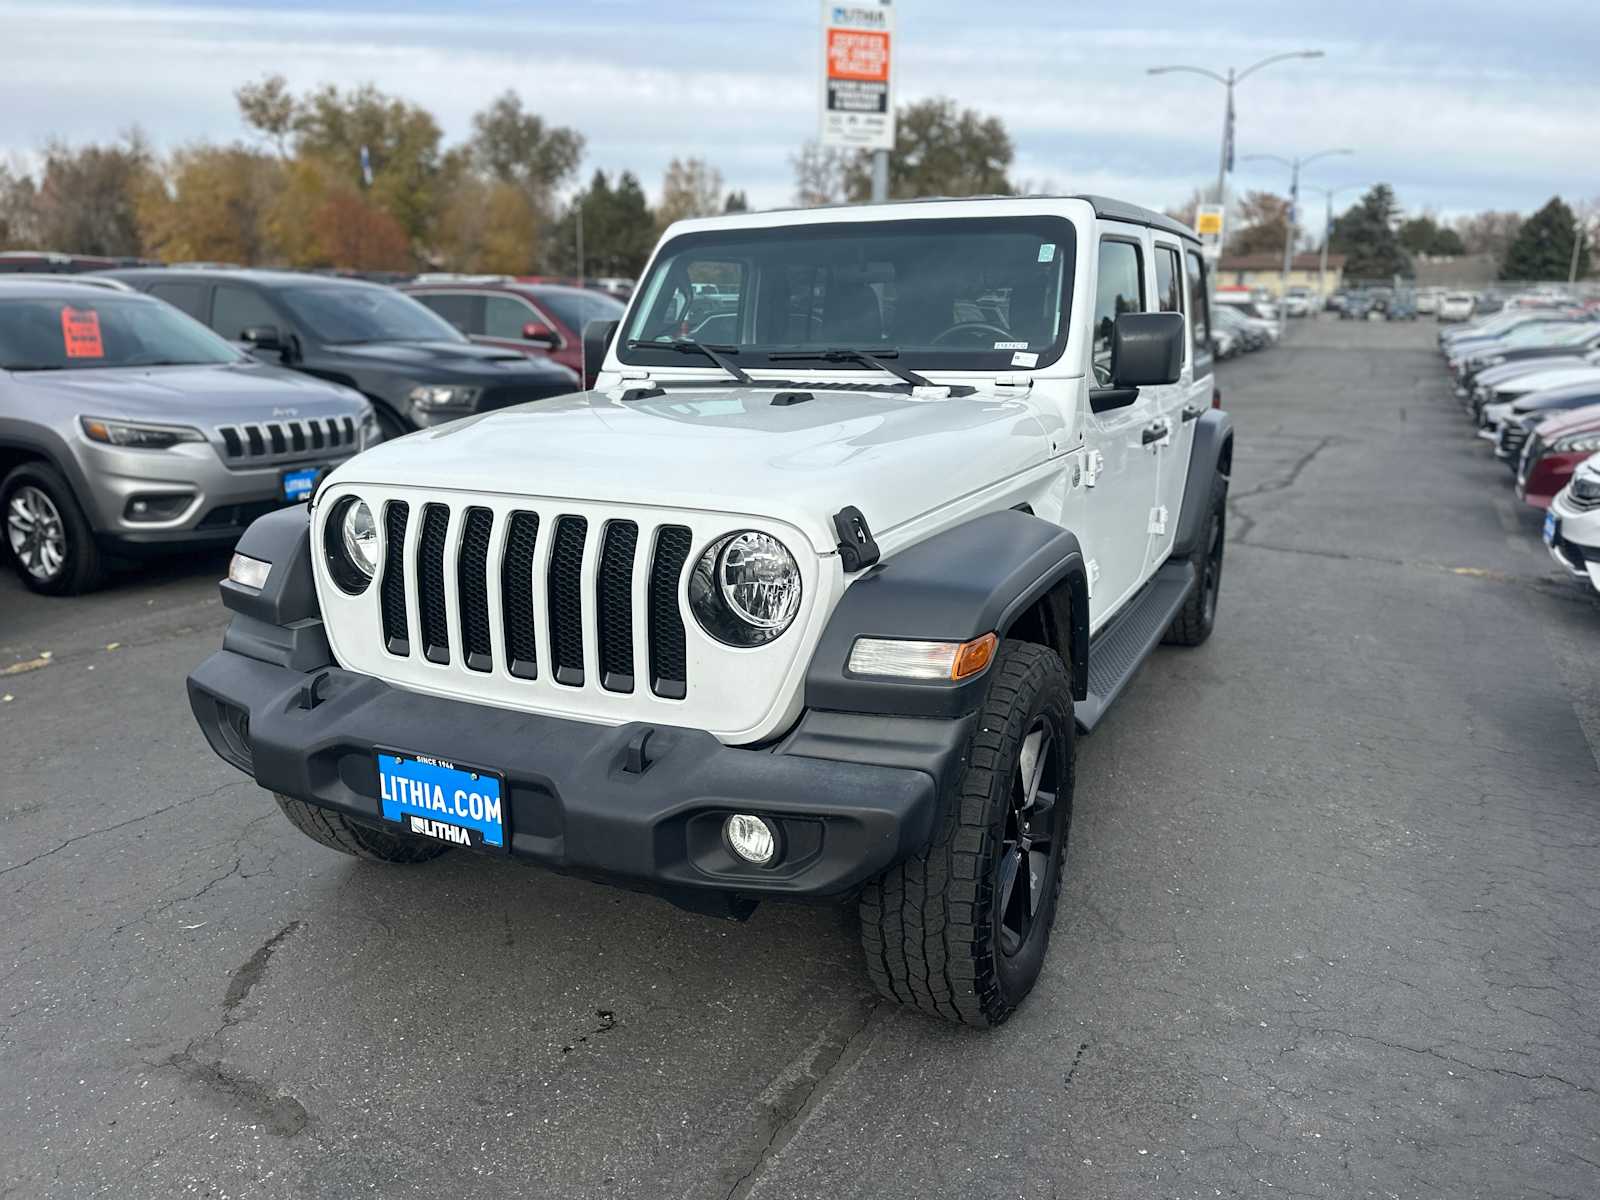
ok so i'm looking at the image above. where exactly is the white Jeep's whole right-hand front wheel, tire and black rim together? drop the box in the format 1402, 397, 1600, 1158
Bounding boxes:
859, 642, 1075, 1027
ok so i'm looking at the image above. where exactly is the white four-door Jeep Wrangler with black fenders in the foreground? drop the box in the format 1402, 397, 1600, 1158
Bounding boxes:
189, 197, 1232, 1026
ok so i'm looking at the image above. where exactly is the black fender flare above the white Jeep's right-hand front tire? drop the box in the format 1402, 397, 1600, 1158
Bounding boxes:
805, 509, 1090, 718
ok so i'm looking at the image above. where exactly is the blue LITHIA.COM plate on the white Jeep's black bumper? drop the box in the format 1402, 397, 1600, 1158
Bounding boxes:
378, 750, 506, 850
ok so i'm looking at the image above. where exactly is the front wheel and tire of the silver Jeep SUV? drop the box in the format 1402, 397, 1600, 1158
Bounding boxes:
0, 462, 106, 595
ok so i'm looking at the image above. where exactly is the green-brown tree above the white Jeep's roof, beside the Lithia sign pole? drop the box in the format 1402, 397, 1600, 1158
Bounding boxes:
843, 98, 1016, 200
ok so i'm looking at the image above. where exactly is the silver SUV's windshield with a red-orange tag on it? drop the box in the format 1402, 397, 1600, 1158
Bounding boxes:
0, 296, 245, 371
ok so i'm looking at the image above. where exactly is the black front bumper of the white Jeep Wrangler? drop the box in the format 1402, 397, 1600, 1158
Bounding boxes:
189, 650, 973, 902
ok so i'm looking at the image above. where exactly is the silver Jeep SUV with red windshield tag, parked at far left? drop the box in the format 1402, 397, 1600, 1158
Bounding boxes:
0, 280, 376, 595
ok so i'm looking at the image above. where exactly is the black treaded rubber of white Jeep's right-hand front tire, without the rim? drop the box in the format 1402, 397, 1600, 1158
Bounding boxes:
858, 642, 1074, 1027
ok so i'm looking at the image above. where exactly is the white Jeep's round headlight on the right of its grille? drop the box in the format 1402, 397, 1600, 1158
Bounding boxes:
690, 530, 800, 646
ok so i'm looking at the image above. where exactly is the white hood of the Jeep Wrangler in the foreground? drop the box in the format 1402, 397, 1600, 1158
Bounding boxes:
333, 384, 1050, 552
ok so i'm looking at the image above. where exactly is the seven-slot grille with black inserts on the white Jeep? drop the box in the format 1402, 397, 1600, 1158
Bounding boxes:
379, 501, 691, 699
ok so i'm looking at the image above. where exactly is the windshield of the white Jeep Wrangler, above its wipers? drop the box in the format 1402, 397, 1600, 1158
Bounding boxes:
618, 216, 1074, 371
